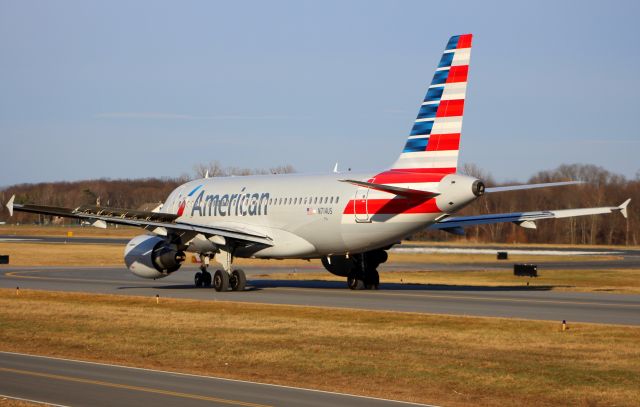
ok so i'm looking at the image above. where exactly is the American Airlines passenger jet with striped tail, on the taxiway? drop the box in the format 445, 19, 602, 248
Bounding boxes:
6, 34, 630, 291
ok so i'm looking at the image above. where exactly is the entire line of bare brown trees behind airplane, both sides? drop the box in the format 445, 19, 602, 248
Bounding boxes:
0, 161, 640, 245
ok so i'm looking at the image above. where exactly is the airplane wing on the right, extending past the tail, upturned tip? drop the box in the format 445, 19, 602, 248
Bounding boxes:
428, 199, 631, 234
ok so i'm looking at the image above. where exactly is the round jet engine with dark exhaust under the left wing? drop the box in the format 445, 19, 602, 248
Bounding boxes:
124, 235, 186, 279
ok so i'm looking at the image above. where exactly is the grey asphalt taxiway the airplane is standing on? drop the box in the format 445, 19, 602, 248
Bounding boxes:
0, 262, 640, 325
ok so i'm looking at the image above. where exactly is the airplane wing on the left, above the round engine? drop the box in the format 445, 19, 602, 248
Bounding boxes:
6, 196, 273, 246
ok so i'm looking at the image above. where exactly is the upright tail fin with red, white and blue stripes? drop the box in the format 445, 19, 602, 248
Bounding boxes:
391, 34, 472, 174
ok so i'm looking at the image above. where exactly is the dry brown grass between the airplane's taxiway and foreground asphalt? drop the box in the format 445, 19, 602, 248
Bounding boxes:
0, 289, 640, 406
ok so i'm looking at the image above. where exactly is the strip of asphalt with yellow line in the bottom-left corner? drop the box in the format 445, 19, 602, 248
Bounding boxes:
0, 352, 430, 407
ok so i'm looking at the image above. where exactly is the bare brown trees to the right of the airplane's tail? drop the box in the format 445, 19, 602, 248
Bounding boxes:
414, 164, 640, 245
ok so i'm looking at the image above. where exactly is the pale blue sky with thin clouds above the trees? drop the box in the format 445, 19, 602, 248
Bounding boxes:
0, 0, 640, 185
